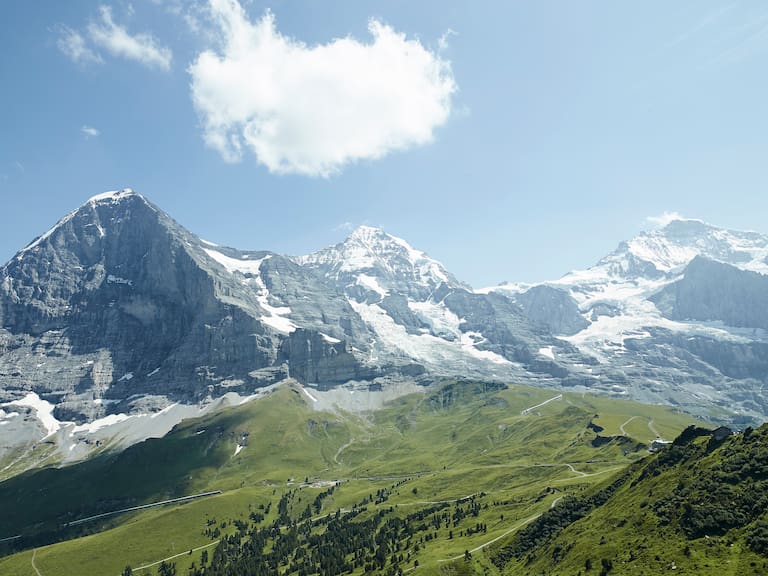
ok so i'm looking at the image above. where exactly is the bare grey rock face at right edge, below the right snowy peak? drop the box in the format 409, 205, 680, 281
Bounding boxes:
651, 257, 768, 330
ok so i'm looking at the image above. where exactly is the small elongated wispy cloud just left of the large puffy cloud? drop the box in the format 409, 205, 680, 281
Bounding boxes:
88, 6, 173, 70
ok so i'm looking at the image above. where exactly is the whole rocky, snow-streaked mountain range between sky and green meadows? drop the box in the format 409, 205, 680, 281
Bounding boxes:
0, 189, 768, 470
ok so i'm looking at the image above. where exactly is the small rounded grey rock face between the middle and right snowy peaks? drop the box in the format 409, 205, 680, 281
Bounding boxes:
515, 285, 589, 336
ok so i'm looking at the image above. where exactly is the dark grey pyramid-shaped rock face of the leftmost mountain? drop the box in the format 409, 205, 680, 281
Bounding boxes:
0, 192, 292, 420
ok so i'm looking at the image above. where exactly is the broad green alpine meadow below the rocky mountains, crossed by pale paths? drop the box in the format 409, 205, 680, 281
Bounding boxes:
0, 382, 704, 575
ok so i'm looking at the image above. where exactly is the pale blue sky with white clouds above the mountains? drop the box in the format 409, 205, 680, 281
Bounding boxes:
0, 0, 768, 287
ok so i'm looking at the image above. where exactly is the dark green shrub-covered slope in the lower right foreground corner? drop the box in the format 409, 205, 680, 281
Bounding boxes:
489, 426, 768, 576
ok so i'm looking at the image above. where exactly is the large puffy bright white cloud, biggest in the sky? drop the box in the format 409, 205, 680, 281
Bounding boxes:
189, 0, 457, 177
